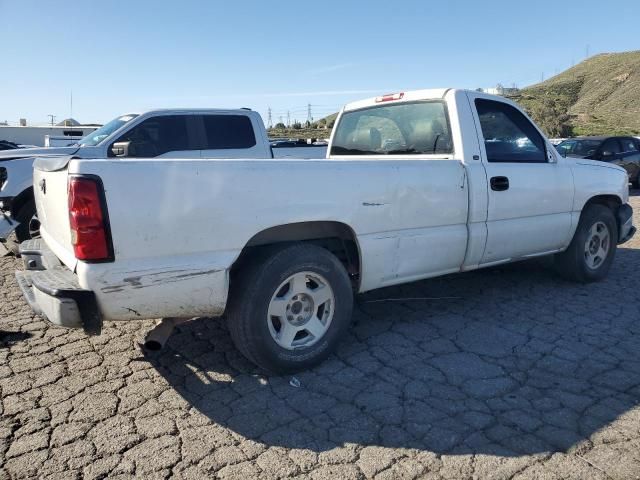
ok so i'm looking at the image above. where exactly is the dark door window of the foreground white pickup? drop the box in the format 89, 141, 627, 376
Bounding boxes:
475, 98, 547, 163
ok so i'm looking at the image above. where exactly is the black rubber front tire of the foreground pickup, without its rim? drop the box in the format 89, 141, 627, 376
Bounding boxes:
555, 204, 618, 283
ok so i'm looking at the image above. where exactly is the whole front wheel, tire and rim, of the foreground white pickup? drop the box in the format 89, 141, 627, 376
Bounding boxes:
555, 204, 618, 283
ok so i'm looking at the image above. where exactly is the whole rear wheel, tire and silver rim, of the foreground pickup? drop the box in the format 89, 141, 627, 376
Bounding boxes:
227, 244, 353, 373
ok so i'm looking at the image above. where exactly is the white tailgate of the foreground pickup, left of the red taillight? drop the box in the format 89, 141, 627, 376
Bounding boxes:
33, 157, 77, 270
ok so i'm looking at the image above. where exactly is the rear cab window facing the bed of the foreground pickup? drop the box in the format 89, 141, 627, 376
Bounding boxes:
330, 100, 453, 156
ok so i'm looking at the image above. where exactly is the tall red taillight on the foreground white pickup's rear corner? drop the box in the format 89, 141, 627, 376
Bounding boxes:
69, 177, 113, 261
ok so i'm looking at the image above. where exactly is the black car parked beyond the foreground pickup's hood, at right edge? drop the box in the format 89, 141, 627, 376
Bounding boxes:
557, 137, 640, 188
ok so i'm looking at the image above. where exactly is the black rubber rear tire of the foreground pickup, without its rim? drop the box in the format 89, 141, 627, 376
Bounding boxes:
226, 243, 353, 374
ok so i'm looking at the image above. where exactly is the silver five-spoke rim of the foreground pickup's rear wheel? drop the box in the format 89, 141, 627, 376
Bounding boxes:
267, 272, 335, 350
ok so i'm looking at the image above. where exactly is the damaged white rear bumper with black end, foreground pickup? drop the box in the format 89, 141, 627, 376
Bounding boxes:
16, 239, 102, 335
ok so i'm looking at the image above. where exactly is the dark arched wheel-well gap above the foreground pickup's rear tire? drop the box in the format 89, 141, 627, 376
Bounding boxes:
231, 221, 361, 289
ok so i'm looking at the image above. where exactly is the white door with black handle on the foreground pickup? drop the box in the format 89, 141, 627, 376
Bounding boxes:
469, 93, 574, 264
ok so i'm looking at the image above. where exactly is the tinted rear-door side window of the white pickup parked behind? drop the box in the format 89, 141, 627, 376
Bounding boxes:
203, 115, 256, 150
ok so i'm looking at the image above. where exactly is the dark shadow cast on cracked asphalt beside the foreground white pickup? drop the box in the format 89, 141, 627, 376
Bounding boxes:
145, 249, 640, 456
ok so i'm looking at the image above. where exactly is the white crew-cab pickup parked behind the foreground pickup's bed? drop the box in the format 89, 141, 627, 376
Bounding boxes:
0, 109, 308, 253
